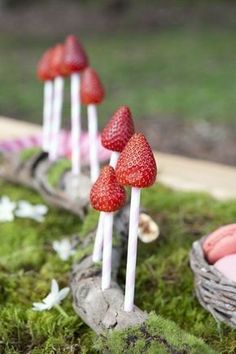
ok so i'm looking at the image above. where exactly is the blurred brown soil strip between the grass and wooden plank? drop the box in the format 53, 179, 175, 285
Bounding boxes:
137, 118, 236, 166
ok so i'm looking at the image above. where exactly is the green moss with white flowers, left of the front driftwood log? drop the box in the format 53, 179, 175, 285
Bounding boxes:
0, 183, 94, 354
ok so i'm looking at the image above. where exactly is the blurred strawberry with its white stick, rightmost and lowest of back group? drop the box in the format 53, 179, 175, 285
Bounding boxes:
80, 67, 104, 182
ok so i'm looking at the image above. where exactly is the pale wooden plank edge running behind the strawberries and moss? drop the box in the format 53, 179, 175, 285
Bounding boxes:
0, 117, 236, 200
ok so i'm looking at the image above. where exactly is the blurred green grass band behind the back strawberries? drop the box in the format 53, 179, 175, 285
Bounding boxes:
0, 27, 236, 125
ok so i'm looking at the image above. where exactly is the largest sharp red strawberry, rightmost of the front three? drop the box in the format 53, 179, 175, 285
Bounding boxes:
116, 134, 157, 188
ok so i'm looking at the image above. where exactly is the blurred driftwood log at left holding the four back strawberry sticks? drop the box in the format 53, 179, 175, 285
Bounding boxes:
0, 152, 90, 218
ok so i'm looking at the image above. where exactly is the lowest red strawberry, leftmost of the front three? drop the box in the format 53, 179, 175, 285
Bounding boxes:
90, 166, 125, 212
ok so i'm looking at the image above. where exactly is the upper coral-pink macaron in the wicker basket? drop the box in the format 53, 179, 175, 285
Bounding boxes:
203, 224, 236, 264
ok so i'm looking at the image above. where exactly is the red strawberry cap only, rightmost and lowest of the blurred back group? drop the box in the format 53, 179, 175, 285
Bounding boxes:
80, 67, 104, 104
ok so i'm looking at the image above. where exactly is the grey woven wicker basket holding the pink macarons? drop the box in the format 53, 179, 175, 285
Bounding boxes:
190, 237, 236, 328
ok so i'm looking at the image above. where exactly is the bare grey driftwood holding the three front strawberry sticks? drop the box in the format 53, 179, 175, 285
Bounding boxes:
71, 206, 148, 334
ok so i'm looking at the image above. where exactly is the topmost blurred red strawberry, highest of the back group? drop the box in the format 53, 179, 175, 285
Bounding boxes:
64, 35, 88, 74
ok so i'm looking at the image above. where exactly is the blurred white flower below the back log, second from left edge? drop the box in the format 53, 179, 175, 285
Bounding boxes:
15, 200, 48, 222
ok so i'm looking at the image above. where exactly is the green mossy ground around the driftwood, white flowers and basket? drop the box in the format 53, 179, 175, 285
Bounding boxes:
0, 182, 236, 354
